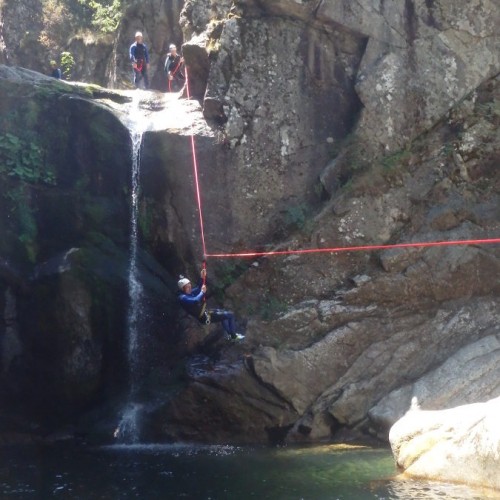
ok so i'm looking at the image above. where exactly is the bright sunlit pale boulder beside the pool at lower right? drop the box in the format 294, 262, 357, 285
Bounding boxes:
389, 398, 500, 490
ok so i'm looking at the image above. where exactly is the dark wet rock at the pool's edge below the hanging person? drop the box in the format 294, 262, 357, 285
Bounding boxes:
152, 356, 296, 444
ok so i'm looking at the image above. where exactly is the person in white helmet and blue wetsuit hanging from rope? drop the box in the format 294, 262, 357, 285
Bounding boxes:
177, 268, 245, 340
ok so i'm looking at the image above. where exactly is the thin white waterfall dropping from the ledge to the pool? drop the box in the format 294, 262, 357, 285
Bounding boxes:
114, 92, 145, 443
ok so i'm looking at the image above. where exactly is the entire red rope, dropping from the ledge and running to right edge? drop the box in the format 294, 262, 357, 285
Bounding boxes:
185, 73, 500, 269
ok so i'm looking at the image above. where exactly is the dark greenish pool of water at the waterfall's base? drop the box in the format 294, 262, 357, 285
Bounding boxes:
0, 444, 485, 500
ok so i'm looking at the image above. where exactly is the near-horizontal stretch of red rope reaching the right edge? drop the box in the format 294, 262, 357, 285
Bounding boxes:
205, 238, 500, 258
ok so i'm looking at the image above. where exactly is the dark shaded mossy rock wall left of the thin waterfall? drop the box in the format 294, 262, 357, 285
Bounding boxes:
0, 66, 182, 428
